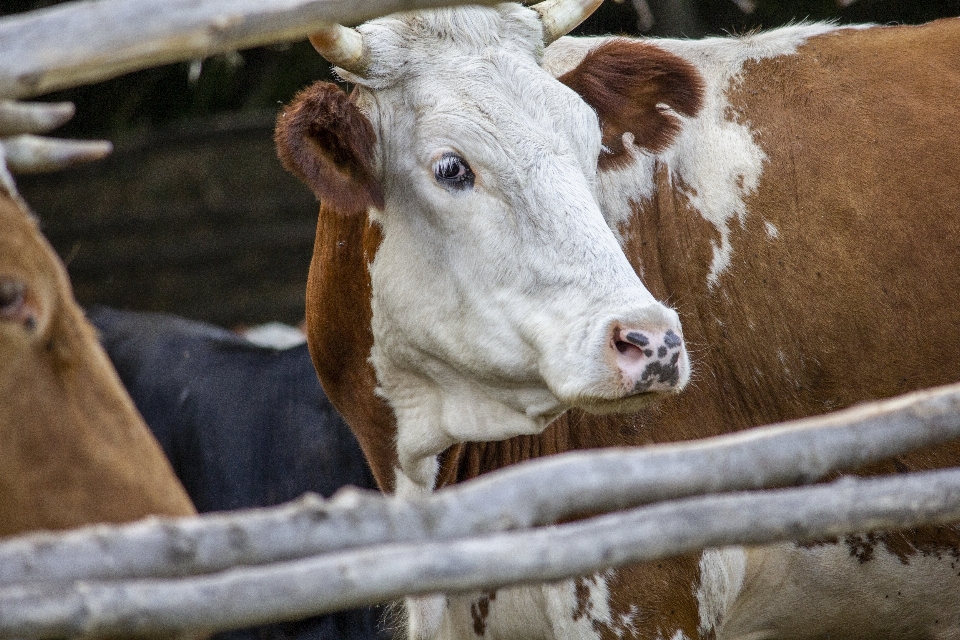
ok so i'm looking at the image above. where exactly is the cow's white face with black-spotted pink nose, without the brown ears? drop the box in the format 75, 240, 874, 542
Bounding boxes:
344, 5, 689, 480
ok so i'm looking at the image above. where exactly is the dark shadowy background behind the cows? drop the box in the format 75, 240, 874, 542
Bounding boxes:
0, 0, 960, 327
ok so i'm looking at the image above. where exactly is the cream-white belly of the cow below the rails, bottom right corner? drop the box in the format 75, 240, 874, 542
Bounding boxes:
715, 535, 960, 640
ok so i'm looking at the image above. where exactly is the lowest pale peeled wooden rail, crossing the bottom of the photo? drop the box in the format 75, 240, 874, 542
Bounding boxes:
0, 469, 960, 638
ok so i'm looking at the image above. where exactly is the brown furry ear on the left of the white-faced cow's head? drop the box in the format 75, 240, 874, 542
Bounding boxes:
274, 82, 383, 213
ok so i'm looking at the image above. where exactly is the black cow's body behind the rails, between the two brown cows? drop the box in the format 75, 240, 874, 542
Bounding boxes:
87, 307, 392, 640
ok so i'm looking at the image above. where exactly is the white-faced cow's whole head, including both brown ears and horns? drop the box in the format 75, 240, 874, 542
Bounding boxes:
277, 2, 702, 483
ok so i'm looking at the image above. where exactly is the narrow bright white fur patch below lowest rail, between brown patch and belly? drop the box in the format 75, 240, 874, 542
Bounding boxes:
696, 547, 747, 637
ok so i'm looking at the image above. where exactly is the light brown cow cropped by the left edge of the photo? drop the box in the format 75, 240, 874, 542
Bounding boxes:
0, 116, 196, 537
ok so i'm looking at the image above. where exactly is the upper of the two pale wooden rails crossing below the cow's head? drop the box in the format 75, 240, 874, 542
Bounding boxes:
0, 385, 960, 585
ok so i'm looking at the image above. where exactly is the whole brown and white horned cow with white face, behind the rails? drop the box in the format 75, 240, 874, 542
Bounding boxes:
276, 0, 960, 640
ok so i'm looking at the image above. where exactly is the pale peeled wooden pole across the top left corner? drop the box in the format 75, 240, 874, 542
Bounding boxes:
0, 0, 495, 98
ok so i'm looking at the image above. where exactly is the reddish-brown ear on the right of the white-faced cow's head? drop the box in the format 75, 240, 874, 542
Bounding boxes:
559, 38, 704, 169
